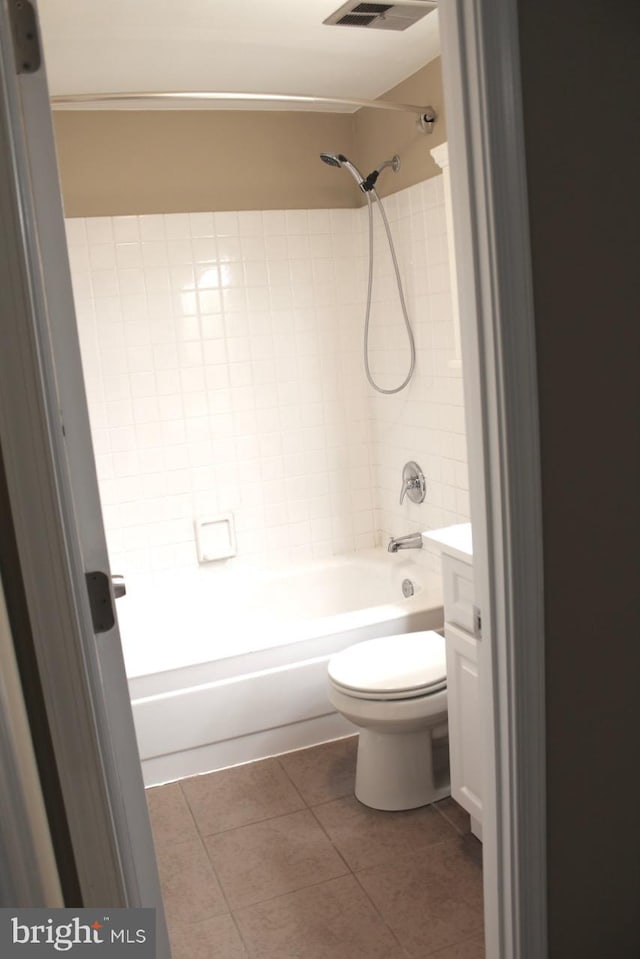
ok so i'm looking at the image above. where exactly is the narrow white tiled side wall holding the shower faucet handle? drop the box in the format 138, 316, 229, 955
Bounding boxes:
359, 177, 470, 570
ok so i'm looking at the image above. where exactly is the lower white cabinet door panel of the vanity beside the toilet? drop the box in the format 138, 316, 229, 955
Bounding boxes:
445, 623, 482, 822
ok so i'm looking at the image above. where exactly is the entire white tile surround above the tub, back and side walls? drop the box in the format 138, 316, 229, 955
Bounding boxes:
67, 178, 468, 588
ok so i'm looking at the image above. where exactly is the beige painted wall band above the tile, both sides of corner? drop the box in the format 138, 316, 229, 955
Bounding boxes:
54, 60, 446, 217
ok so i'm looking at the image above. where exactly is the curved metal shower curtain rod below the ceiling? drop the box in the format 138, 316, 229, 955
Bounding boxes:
51, 90, 437, 132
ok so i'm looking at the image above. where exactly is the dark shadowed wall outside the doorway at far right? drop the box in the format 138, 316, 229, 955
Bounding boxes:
518, 0, 640, 959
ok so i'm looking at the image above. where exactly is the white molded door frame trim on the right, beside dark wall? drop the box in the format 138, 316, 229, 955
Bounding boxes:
439, 0, 547, 959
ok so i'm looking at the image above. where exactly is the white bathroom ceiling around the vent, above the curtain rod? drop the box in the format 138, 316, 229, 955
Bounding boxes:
38, 0, 439, 109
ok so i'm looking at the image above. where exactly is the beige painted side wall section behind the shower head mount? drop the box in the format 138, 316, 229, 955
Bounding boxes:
355, 57, 447, 202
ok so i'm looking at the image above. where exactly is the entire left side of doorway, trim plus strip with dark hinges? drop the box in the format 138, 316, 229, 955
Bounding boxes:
0, 0, 170, 959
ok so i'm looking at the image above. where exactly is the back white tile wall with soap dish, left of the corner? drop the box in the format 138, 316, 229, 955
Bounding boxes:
67, 210, 375, 573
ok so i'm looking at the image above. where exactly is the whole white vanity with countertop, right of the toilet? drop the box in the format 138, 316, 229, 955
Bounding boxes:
423, 523, 483, 839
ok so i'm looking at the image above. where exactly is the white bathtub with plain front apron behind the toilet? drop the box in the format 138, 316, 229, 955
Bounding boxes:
118, 549, 443, 785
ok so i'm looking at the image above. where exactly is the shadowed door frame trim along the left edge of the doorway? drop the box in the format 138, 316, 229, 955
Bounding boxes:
0, 20, 124, 905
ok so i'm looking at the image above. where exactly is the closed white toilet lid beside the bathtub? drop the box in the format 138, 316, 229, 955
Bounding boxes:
329, 630, 447, 695
